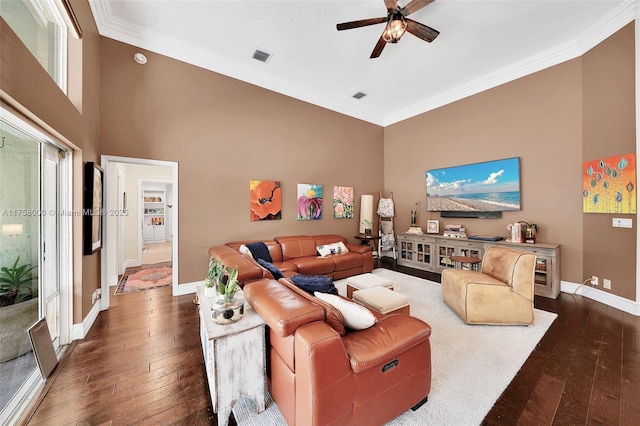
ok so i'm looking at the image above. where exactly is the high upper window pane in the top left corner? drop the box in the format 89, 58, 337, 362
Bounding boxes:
0, 0, 67, 93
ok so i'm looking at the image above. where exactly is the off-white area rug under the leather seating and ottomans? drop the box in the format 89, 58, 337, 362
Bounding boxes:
233, 269, 557, 426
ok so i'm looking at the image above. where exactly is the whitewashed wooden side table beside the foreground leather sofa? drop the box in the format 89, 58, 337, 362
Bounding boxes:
197, 286, 266, 426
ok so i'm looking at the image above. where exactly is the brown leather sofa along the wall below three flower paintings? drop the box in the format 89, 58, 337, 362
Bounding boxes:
209, 234, 373, 286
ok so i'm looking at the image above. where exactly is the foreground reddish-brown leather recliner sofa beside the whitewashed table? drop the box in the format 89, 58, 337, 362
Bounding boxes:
244, 278, 431, 426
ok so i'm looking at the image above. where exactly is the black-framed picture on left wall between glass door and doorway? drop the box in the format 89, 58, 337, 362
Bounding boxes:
82, 161, 104, 255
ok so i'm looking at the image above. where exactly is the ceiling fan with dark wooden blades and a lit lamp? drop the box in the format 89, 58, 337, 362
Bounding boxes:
336, 0, 440, 58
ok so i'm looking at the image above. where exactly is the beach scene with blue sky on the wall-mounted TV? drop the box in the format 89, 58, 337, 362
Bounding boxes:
426, 157, 520, 212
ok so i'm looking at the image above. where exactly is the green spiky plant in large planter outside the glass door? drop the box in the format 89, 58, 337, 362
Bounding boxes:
0, 256, 38, 362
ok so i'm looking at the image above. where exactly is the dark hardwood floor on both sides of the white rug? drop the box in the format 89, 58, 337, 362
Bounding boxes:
25, 259, 640, 426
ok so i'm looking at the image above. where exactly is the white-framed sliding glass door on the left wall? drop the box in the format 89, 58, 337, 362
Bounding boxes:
0, 110, 68, 419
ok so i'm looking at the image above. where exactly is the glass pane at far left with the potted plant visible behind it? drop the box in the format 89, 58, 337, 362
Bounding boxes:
0, 118, 40, 409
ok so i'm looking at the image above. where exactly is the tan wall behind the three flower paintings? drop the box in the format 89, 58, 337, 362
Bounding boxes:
100, 38, 383, 283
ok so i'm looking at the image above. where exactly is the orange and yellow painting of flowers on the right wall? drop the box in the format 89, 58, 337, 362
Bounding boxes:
582, 153, 637, 214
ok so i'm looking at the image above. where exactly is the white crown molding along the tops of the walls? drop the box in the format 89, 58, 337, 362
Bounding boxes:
89, 0, 640, 127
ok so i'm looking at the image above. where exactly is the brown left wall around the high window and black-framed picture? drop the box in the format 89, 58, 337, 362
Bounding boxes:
0, 2, 100, 323
